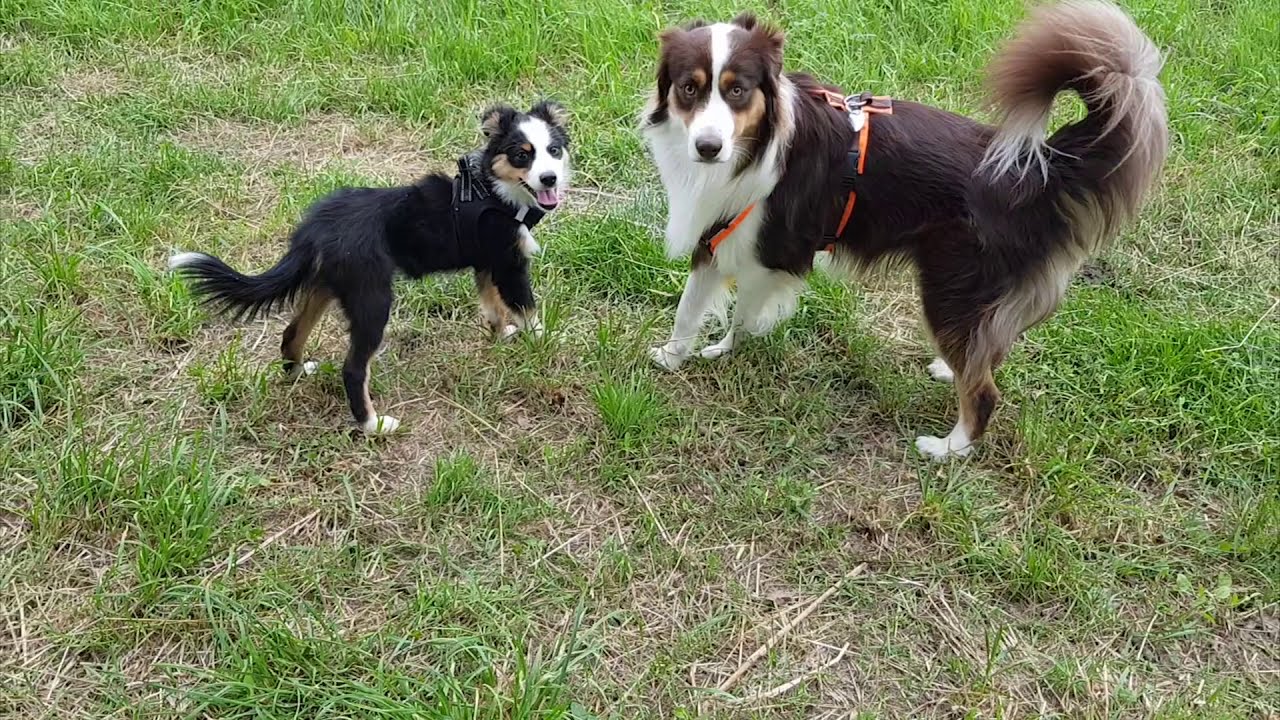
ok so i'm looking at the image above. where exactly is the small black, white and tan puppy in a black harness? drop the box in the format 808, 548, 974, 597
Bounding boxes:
169, 101, 570, 433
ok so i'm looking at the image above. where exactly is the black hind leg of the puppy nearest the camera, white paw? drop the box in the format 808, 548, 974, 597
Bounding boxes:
340, 287, 399, 434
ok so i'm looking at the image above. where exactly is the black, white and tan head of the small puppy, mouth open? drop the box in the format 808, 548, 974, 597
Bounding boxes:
480, 101, 570, 210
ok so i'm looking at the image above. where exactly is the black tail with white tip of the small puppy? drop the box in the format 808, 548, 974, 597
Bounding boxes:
169, 247, 315, 320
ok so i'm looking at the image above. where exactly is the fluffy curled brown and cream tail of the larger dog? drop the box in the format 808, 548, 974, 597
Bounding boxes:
982, 0, 1169, 245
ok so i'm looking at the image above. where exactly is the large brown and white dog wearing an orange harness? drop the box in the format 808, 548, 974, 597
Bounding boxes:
641, 0, 1169, 459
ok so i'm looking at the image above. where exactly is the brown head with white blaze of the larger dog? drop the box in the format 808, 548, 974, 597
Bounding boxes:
648, 13, 783, 163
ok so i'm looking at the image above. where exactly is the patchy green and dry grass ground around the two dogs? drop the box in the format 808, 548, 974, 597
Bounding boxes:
0, 0, 1280, 720
